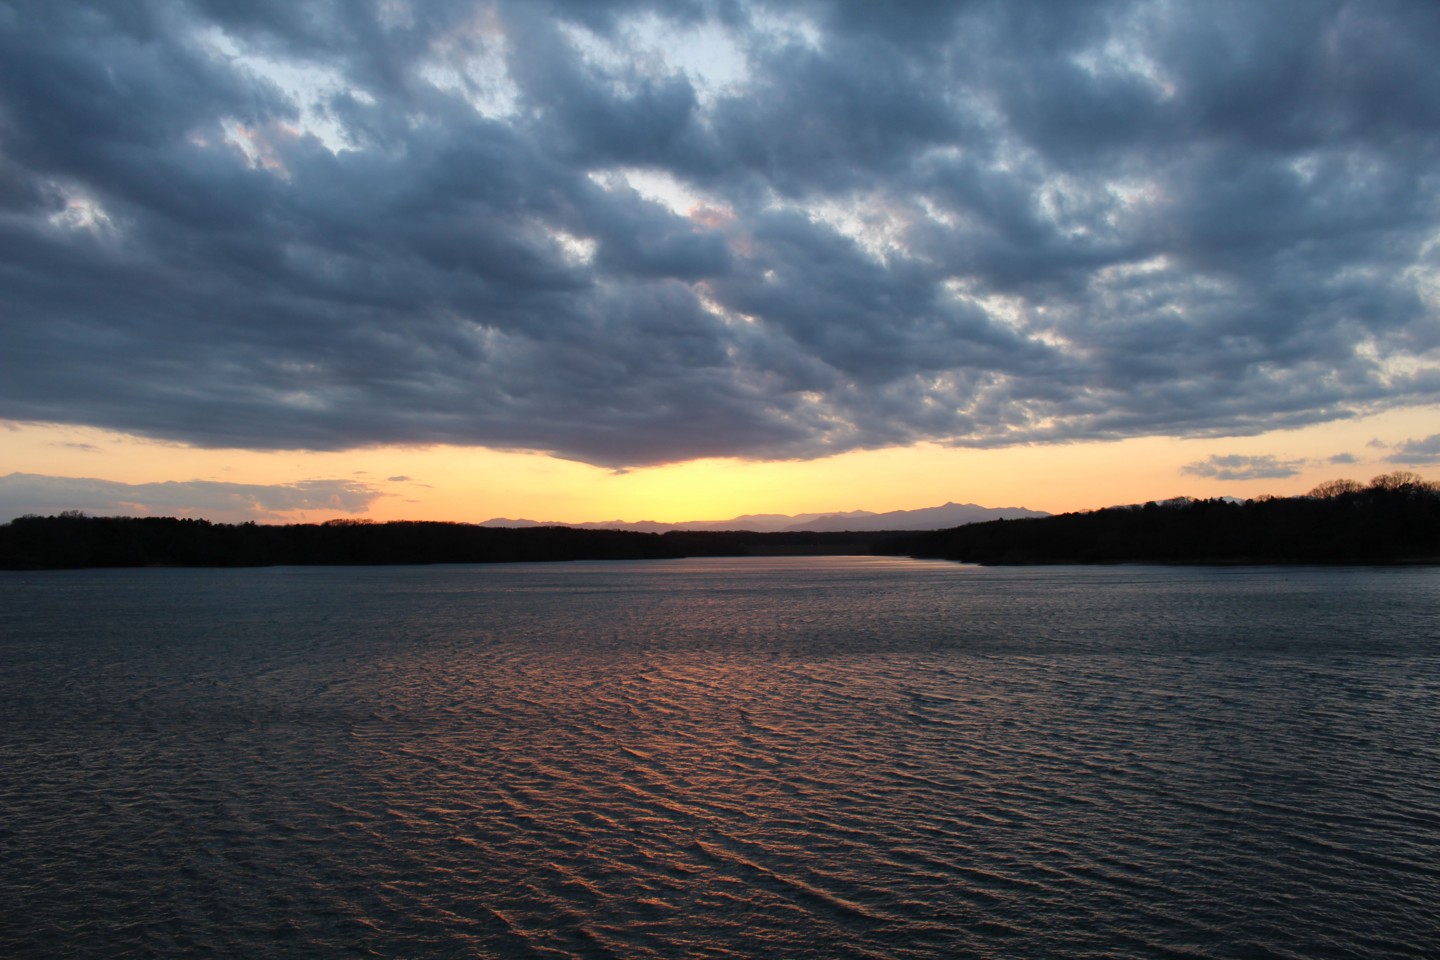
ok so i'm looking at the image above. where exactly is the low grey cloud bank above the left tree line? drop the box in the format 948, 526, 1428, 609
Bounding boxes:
0, 474, 382, 522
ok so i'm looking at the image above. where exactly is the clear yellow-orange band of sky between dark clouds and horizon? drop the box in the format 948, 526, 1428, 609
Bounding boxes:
0, 407, 1440, 522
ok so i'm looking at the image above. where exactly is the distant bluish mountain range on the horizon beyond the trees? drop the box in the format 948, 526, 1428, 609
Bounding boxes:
480, 504, 1050, 534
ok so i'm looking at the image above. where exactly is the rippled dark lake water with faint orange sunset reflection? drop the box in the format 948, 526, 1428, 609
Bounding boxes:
0, 557, 1440, 959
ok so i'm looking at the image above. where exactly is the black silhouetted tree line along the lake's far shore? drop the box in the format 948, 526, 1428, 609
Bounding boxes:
0, 471, 1440, 570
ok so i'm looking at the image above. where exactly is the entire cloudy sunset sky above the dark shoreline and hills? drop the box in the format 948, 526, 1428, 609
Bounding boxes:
0, 0, 1440, 522
